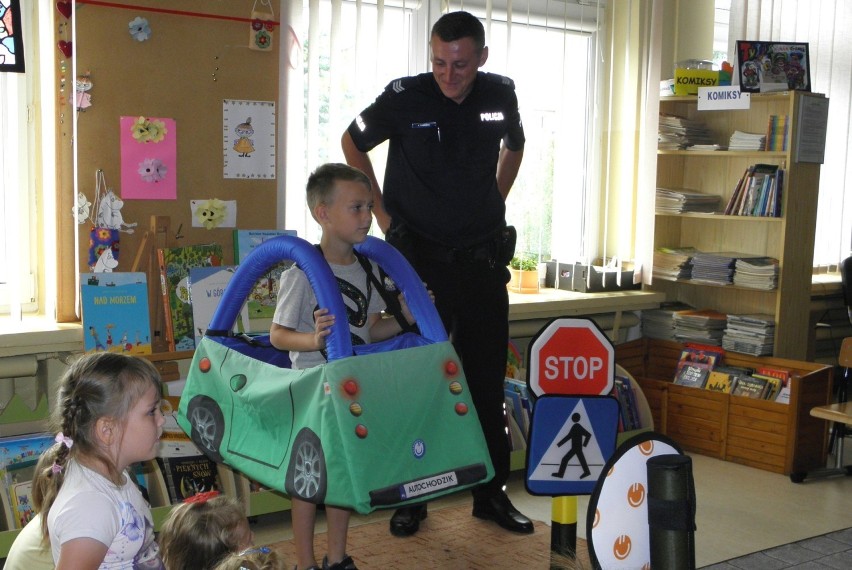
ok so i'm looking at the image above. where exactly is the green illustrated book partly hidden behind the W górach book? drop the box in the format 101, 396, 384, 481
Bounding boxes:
157, 243, 222, 351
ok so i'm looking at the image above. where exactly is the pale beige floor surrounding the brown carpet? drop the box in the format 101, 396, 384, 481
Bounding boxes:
248, 444, 852, 570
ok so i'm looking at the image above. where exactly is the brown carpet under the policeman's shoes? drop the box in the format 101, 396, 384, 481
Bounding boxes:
271, 505, 591, 570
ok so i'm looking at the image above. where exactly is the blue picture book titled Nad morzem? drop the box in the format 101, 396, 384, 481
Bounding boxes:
80, 272, 151, 354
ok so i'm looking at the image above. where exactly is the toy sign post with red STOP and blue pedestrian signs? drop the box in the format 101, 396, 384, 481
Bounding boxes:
527, 318, 618, 557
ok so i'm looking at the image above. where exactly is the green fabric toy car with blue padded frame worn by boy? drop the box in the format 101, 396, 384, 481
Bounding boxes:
178, 236, 494, 513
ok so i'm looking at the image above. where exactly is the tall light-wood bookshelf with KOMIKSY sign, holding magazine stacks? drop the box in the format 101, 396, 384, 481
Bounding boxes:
648, 91, 823, 360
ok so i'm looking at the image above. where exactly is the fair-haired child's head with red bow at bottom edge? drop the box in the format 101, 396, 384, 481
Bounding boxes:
158, 495, 253, 570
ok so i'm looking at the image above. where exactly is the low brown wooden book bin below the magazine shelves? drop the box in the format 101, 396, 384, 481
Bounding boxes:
615, 338, 833, 482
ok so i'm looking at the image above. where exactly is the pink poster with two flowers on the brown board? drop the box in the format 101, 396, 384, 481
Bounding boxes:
120, 113, 177, 200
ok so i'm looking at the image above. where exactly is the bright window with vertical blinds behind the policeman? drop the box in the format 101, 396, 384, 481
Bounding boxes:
285, 0, 599, 266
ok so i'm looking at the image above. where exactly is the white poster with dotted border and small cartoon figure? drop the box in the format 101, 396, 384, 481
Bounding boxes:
222, 99, 275, 180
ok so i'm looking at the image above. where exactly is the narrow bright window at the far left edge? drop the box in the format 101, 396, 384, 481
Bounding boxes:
0, 0, 55, 319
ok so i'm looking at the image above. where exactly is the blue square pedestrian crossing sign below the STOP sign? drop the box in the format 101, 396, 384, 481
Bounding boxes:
527, 395, 618, 497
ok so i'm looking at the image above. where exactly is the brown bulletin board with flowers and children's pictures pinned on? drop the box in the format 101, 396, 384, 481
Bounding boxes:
73, 0, 283, 272
